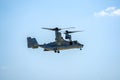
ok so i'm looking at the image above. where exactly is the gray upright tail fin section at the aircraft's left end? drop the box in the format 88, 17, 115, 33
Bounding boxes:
27, 37, 39, 48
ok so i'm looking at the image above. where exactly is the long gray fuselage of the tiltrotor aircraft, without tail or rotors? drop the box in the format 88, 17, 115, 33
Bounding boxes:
40, 41, 83, 51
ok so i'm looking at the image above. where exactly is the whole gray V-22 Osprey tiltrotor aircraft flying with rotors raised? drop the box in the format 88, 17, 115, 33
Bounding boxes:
27, 27, 84, 53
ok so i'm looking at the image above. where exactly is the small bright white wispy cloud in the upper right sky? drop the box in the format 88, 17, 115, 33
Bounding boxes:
94, 7, 120, 16
